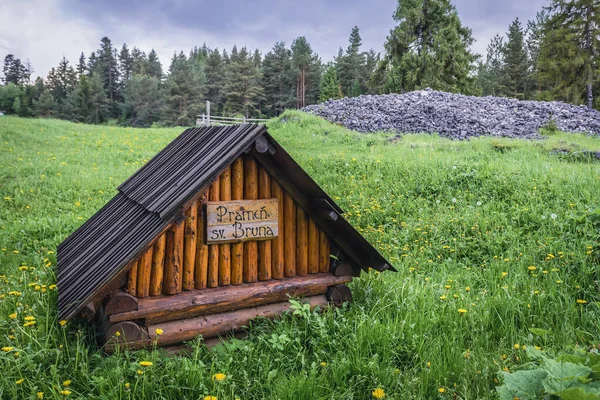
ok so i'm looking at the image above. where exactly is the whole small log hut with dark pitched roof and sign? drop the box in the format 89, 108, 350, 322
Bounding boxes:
57, 124, 395, 348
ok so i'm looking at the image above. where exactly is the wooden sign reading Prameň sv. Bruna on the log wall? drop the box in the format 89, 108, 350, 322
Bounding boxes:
206, 199, 279, 244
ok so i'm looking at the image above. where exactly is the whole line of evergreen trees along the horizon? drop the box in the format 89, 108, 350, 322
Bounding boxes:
0, 0, 600, 127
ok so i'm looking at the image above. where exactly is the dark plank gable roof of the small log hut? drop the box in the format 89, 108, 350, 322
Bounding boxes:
57, 124, 394, 319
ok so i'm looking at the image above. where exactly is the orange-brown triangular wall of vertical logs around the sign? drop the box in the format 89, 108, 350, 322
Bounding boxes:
126, 155, 330, 297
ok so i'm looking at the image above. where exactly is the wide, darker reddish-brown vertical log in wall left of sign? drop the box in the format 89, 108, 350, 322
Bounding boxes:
163, 223, 185, 294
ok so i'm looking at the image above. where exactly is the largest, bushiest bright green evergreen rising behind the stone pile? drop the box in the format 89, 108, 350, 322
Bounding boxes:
382, 0, 477, 94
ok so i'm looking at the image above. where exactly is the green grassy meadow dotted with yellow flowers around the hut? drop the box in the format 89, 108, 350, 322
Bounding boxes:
0, 112, 600, 400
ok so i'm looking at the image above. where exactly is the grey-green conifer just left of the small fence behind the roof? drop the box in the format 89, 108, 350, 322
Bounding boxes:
161, 52, 204, 126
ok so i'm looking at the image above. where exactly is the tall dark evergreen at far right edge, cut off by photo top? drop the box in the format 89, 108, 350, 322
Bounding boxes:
538, 0, 600, 108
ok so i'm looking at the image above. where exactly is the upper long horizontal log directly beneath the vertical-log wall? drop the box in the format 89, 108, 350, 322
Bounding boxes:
110, 273, 352, 324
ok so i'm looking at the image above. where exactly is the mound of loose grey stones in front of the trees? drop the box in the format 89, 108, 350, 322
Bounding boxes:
303, 89, 600, 140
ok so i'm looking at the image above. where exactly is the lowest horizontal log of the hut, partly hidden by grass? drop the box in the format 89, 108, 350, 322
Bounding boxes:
148, 295, 327, 346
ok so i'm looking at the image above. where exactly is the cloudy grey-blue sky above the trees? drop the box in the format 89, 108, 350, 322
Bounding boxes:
0, 0, 547, 76
